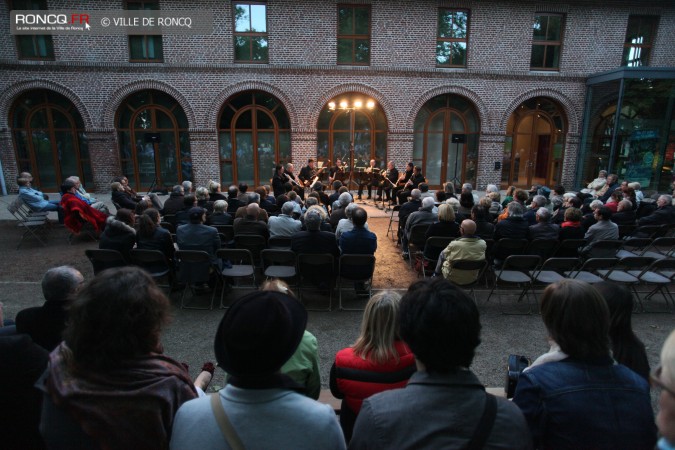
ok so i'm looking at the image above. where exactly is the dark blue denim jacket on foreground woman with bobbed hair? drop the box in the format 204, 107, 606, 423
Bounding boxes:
513, 356, 656, 450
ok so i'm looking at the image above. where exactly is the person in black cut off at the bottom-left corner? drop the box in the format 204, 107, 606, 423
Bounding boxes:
0, 332, 48, 450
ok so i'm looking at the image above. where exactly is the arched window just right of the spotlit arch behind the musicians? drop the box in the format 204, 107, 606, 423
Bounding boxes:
413, 94, 480, 188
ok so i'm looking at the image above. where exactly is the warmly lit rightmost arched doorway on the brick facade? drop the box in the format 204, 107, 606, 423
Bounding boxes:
501, 97, 567, 189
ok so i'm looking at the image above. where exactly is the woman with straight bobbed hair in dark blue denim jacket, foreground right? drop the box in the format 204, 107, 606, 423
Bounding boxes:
516, 280, 656, 449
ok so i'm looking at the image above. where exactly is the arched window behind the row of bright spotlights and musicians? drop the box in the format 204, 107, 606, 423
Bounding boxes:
316, 92, 387, 168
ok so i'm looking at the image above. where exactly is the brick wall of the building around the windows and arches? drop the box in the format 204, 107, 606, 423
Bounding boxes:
0, 0, 675, 190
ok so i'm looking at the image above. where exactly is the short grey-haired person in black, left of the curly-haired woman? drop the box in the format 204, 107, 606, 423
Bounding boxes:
15, 266, 84, 352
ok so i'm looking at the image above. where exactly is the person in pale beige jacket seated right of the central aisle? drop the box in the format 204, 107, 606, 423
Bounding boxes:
435, 219, 487, 285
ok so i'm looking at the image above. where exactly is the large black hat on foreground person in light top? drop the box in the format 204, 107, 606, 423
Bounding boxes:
213, 291, 307, 377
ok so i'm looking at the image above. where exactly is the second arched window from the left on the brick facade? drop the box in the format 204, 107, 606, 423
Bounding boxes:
116, 90, 192, 191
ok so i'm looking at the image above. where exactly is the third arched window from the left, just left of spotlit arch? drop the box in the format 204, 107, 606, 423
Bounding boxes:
218, 91, 291, 186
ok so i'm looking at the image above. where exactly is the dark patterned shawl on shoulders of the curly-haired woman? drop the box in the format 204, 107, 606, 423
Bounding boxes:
46, 342, 197, 449
